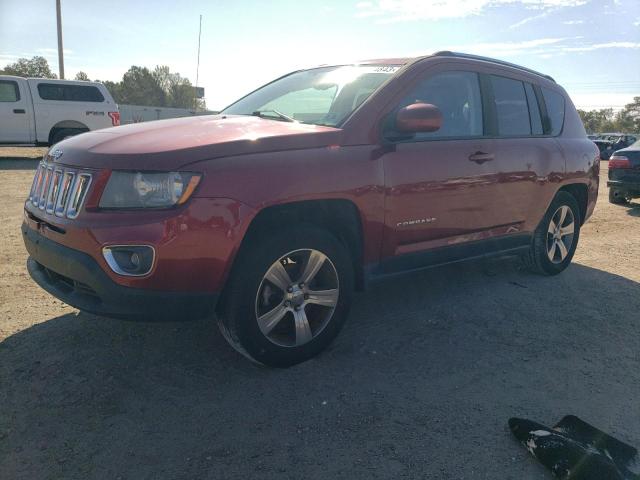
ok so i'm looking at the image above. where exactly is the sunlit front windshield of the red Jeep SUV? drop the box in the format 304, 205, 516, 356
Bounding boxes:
221, 65, 400, 127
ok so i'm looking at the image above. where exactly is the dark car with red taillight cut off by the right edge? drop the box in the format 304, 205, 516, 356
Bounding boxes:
607, 141, 640, 204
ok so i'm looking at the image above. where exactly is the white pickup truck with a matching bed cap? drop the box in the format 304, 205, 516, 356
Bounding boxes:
0, 75, 120, 145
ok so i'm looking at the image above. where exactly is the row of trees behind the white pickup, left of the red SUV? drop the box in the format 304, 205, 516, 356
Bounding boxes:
0, 56, 206, 110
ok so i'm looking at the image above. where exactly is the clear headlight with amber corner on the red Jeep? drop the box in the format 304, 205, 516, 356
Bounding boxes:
100, 170, 202, 208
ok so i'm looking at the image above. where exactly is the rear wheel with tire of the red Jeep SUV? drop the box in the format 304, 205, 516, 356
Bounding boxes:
524, 192, 581, 275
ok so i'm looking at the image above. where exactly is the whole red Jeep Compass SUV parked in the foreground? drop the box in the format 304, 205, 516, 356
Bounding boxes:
22, 52, 599, 366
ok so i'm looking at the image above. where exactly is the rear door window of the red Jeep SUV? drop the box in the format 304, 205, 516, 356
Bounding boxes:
491, 75, 531, 136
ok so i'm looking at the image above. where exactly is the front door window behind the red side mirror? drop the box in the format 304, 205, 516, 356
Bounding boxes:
400, 71, 483, 140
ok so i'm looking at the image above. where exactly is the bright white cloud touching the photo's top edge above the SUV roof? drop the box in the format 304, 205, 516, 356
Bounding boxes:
356, 0, 587, 23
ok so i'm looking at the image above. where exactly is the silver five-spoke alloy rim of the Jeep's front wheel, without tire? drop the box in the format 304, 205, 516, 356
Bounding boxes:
255, 249, 340, 347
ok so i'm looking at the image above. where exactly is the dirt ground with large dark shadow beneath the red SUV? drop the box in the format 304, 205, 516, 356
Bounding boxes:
0, 149, 640, 480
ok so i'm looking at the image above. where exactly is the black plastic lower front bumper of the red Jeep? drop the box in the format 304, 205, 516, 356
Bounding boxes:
22, 223, 218, 320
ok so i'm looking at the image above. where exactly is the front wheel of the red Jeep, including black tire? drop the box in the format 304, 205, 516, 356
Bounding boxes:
218, 226, 354, 367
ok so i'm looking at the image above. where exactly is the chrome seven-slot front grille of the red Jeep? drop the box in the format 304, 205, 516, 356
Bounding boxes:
29, 160, 91, 218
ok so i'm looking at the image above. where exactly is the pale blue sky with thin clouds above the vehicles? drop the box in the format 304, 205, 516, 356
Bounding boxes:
0, 0, 640, 109
